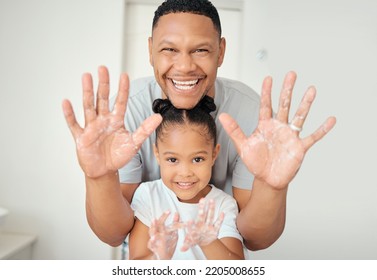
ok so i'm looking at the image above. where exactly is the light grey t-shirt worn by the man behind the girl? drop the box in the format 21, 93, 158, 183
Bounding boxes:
119, 77, 260, 194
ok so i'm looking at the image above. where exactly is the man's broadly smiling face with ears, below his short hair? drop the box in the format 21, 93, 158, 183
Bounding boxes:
149, 13, 225, 109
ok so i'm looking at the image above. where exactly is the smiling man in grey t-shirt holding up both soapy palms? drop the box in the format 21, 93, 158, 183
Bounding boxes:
63, 0, 335, 250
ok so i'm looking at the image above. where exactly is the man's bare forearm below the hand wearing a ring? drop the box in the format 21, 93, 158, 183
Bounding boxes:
237, 180, 288, 251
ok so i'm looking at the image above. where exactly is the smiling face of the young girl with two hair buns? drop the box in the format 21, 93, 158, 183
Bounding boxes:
154, 124, 220, 203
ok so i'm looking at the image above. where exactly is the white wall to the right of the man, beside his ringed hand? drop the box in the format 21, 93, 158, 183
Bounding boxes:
242, 0, 377, 259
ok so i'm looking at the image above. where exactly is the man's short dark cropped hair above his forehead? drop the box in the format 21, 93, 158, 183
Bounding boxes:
152, 0, 221, 37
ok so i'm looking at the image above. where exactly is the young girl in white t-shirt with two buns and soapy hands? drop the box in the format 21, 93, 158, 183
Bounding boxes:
129, 96, 244, 259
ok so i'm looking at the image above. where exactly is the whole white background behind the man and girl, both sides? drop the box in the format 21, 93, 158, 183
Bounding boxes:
0, 0, 377, 259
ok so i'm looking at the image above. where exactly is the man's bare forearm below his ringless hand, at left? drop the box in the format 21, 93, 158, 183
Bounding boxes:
85, 172, 134, 246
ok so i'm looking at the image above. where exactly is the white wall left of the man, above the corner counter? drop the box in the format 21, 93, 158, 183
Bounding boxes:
0, 0, 124, 259
